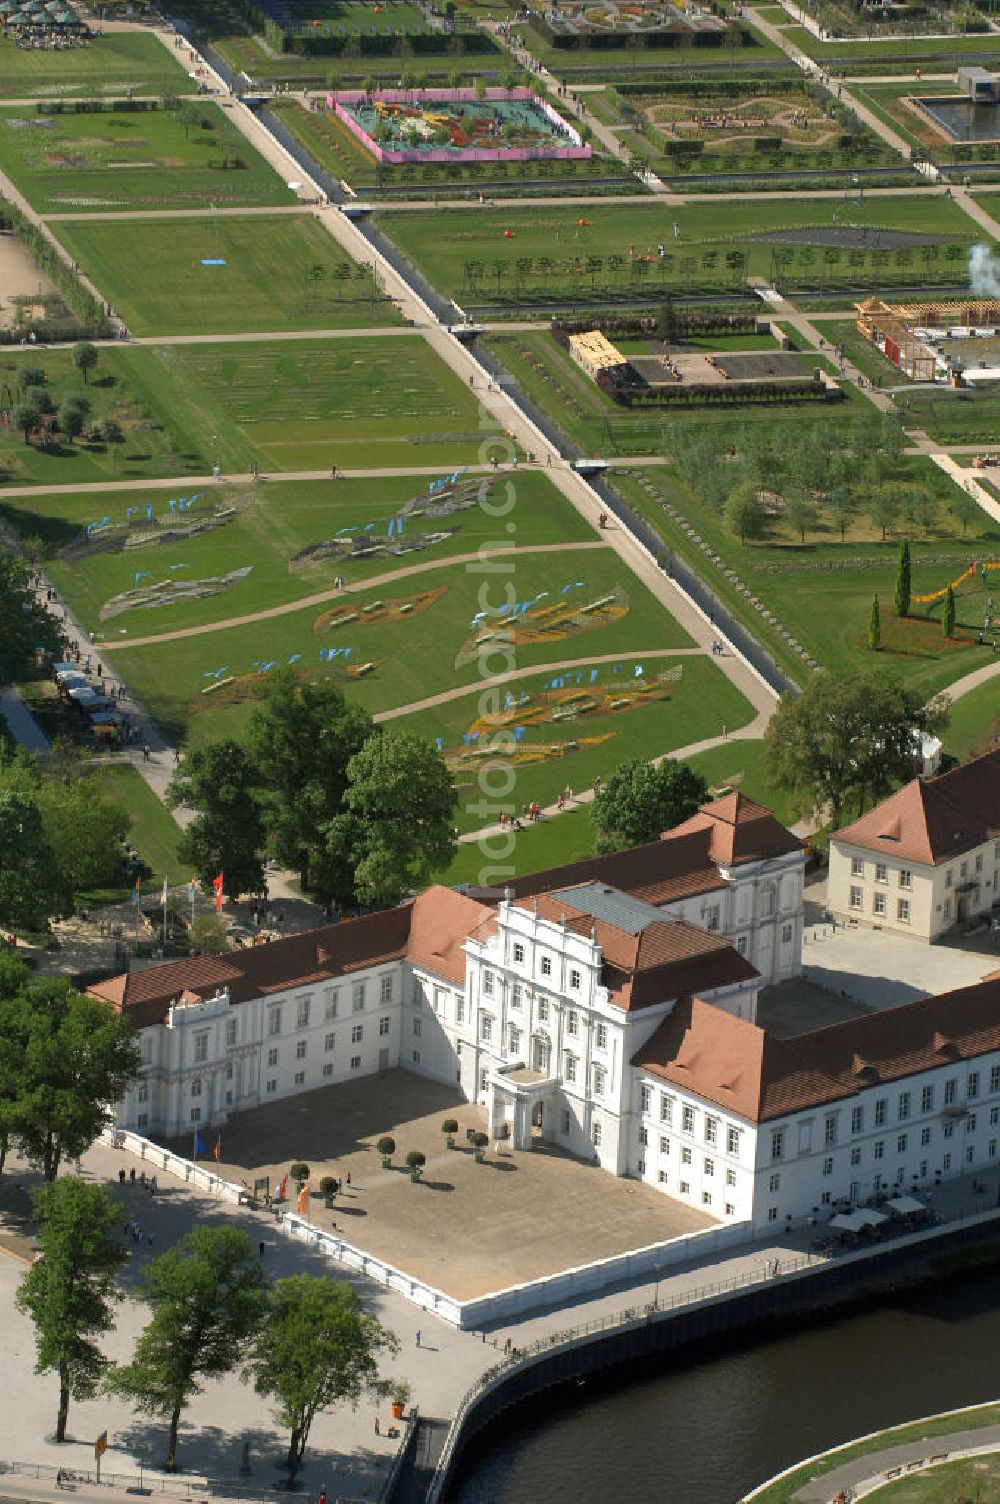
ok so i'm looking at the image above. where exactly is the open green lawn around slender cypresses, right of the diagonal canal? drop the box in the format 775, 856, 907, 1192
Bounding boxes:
615, 460, 997, 695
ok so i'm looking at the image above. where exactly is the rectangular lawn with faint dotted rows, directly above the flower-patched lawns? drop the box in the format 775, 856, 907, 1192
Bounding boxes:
132, 338, 481, 469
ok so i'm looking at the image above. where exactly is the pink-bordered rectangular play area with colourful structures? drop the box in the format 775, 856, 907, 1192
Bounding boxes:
326, 89, 591, 162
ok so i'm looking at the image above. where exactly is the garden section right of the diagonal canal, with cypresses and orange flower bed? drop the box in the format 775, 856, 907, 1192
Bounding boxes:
615, 441, 1000, 696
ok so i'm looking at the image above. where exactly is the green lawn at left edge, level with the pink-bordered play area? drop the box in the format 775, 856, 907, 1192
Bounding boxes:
0, 101, 296, 214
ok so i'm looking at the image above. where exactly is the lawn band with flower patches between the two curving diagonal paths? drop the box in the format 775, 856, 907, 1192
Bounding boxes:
105, 549, 694, 744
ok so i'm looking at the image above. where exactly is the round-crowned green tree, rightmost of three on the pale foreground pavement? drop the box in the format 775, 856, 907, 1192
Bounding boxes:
248, 1274, 400, 1484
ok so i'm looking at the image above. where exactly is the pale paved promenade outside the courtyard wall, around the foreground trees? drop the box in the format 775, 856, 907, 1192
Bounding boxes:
0, 1145, 803, 1504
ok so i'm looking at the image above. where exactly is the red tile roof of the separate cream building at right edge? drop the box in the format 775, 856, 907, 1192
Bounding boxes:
833, 749, 1000, 866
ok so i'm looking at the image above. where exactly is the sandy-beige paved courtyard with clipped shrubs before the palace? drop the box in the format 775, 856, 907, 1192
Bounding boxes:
171, 1071, 713, 1299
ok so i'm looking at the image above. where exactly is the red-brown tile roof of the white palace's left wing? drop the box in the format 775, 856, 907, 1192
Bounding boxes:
90, 887, 495, 1029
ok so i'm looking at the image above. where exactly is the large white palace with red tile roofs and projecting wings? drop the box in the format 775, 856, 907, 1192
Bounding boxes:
92, 794, 1000, 1227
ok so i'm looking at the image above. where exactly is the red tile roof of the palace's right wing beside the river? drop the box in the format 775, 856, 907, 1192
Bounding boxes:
633, 973, 1000, 1122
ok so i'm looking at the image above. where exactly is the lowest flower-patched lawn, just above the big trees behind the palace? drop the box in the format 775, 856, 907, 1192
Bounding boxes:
392, 654, 753, 836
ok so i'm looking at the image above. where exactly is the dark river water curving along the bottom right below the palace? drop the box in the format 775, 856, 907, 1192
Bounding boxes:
448, 1271, 1000, 1504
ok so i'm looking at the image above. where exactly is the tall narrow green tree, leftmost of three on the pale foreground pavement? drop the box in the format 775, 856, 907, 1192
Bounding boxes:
15, 1176, 126, 1441
